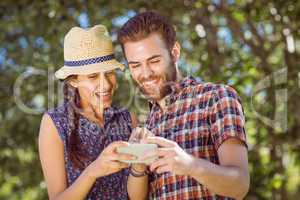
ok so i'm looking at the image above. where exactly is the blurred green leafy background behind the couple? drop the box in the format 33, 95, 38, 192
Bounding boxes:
0, 0, 300, 200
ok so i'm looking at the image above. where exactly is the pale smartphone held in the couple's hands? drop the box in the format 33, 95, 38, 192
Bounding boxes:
117, 143, 158, 165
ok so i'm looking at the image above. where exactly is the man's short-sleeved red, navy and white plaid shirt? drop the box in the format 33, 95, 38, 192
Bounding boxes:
146, 77, 247, 200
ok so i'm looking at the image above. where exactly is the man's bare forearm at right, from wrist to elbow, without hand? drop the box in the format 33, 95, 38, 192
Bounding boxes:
187, 158, 250, 199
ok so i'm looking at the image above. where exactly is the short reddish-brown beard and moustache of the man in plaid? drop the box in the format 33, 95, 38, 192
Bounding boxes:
136, 62, 177, 101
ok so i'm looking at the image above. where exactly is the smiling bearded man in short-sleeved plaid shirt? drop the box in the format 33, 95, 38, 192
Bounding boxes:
118, 12, 249, 200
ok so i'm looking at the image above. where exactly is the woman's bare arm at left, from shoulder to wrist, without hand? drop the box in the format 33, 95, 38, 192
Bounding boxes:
39, 114, 95, 200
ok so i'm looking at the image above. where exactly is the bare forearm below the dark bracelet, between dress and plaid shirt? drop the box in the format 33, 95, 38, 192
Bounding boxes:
127, 175, 148, 200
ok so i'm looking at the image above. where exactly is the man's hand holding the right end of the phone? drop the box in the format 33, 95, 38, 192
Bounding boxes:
142, 137, 195, 175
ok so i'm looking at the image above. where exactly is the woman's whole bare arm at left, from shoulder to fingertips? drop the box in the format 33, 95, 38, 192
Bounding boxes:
39, 114, 135, 200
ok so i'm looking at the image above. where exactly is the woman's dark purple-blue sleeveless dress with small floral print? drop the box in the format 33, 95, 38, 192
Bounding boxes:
47, 103, 132, 200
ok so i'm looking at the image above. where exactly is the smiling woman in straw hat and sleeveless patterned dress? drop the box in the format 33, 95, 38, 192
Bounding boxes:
39, 25, 135, 200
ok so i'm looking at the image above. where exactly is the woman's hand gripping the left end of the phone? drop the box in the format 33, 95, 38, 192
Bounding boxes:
88, 141, 136, 178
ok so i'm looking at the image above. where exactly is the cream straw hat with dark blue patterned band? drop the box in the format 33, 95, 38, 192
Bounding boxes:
55, 25, 124, 79
